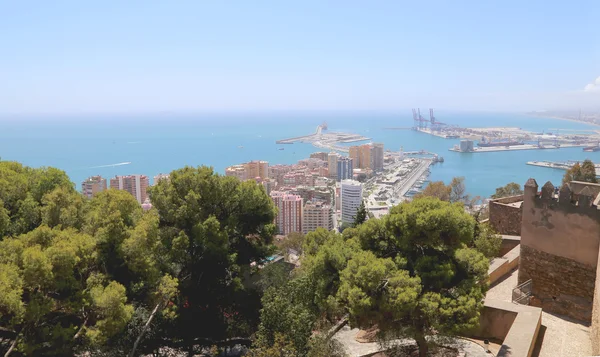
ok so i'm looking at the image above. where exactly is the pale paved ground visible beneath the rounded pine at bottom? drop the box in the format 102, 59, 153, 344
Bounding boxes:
334, 325, 492, 357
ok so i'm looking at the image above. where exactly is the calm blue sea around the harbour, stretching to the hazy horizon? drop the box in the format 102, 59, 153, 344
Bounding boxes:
0, 110, 600, 197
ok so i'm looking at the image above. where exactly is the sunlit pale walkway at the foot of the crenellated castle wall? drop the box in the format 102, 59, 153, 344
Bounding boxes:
486, 270, 592, 357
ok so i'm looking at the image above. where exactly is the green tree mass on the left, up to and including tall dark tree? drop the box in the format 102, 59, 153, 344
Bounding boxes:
0, 162, 275, 356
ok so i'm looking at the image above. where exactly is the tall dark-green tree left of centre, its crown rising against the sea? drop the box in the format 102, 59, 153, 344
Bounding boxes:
150, 167, 275, 348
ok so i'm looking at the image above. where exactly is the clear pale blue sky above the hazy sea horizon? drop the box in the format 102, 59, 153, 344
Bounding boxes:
0, 0, 600, 114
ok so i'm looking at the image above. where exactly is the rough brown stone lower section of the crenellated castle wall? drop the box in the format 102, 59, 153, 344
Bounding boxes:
519, 244, 596, 322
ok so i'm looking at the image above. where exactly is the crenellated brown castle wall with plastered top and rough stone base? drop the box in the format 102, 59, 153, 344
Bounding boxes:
519, 180, 600, 322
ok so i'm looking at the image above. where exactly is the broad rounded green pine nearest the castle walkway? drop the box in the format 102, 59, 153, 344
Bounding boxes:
303, 198, 489, 356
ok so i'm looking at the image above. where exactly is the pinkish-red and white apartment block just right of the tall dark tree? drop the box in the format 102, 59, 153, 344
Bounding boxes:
271, 191, 303, 235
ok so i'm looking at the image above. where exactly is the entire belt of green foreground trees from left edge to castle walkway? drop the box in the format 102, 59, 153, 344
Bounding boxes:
0, 161, 499, 357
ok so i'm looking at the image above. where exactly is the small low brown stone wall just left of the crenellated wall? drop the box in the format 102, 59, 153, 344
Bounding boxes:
489, 195, 523, 236
